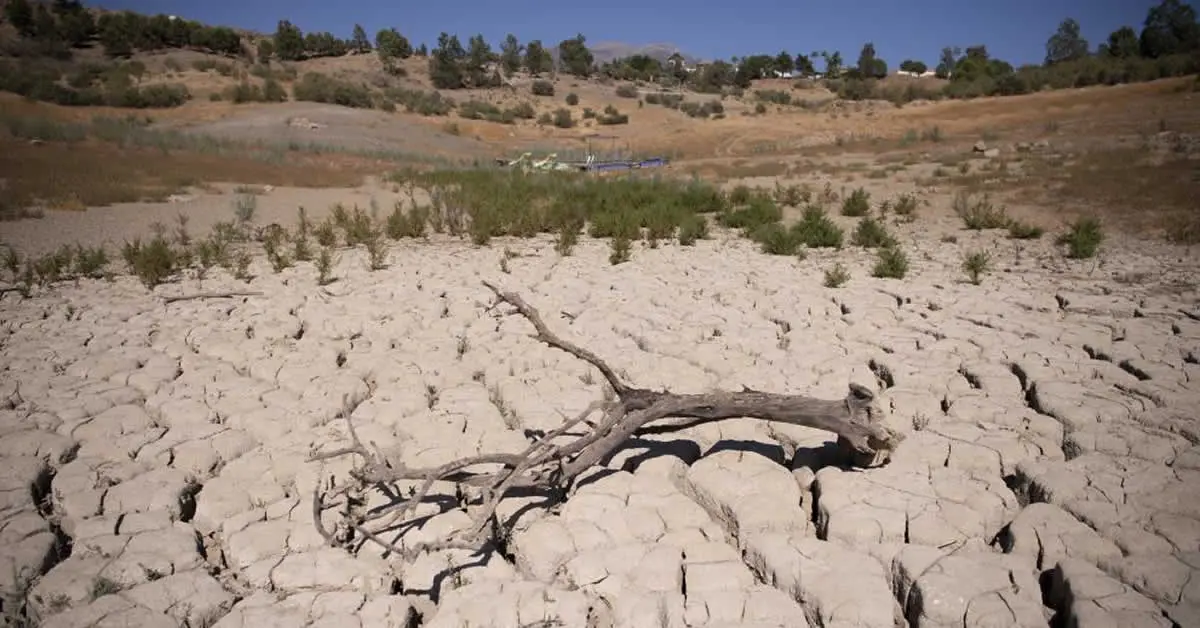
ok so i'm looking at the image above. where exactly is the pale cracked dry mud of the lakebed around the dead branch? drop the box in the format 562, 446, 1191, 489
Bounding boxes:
0, 233, 1200, 628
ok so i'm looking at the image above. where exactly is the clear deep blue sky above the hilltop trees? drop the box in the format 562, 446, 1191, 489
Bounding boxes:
93, 0, 1161, 68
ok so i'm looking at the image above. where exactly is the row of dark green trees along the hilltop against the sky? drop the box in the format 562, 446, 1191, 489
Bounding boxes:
0, 0, 1200, 109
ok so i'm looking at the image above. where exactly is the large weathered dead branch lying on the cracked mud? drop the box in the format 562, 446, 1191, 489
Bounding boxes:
310, 281, 902, 558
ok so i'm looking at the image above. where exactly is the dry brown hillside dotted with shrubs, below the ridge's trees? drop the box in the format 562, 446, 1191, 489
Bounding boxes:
0, 1, 1200, 252
